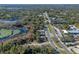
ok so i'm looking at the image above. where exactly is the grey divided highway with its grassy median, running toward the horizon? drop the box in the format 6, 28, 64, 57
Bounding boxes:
43, 12, 73, 54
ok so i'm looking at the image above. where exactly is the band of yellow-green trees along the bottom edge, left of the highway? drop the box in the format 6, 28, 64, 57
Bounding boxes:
0, 41, 58, 54
